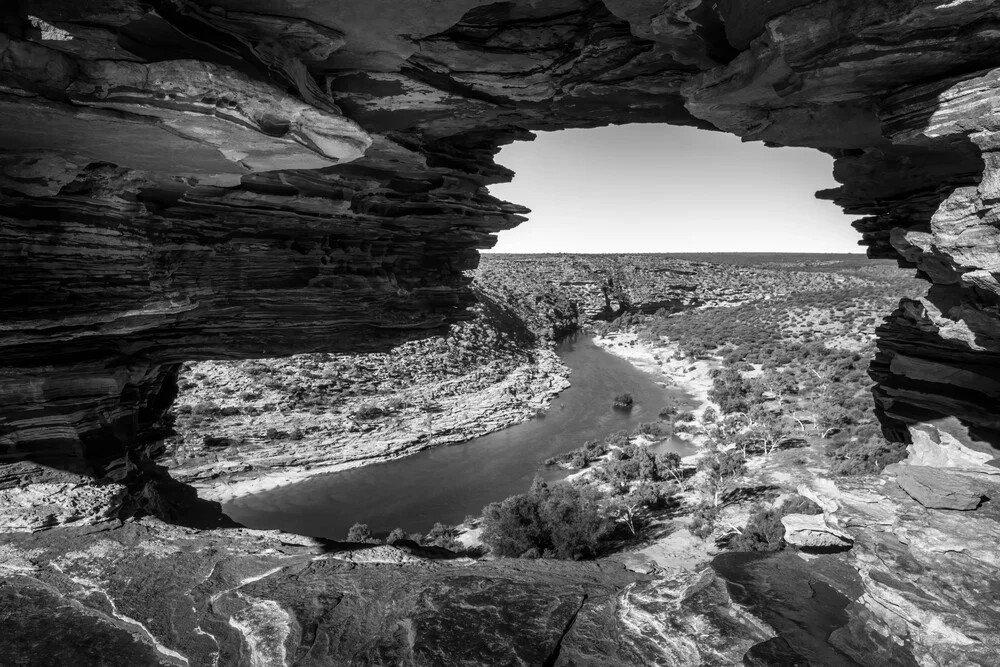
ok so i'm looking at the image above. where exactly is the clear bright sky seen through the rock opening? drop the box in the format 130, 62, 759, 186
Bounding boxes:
490, 125, 864, 253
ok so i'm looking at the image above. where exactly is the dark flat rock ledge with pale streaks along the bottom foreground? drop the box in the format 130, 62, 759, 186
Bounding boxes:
0, 519, 766, 666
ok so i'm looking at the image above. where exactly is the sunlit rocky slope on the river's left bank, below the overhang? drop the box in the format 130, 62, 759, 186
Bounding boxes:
164, 299, 570, 502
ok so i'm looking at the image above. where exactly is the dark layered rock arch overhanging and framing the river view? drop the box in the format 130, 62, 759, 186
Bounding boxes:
0, 0, 1000, 520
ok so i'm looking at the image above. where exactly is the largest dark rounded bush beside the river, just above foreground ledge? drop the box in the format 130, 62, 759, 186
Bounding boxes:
482, 478, 613, 560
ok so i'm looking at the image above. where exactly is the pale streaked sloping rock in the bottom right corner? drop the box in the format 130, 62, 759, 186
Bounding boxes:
810, 470, 1000, 665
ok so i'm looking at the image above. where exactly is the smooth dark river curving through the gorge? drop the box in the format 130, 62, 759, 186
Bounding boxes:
223, 336, 694, 539
